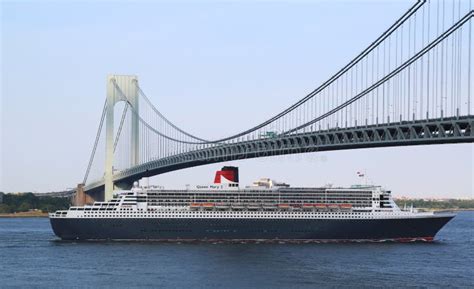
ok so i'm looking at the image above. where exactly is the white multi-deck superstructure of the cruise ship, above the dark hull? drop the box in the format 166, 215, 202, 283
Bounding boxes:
51, 181, 432, 219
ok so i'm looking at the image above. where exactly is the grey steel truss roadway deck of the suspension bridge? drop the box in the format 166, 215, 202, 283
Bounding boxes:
84, 115, 474, 194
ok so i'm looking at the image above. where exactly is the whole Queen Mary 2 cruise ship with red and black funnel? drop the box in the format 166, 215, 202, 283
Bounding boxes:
49, 167, 454, 242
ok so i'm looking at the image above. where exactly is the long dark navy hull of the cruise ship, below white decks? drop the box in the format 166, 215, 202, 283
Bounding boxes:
50, 215, 453, 242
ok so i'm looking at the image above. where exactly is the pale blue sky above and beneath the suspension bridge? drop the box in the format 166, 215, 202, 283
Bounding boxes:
0, 1, 474, 197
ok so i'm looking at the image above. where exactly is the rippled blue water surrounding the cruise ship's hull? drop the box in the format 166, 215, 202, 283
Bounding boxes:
0, 212, 474, 289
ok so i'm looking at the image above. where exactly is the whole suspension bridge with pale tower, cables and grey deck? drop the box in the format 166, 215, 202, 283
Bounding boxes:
76, 0, 474, 204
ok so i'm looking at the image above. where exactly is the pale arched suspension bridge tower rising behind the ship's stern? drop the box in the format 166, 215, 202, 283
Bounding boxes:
104, 75, 139, 201
